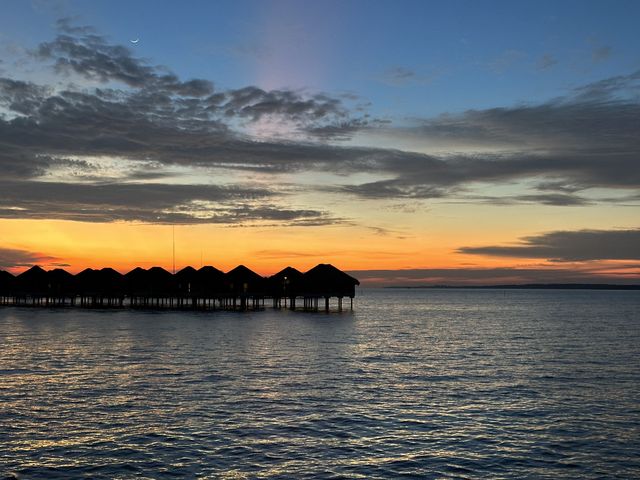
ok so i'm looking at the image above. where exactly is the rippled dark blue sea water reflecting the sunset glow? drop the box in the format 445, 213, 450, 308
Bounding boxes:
0, 290, 640, 479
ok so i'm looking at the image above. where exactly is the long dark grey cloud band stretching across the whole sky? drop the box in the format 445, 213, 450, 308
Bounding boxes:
6, 61, 640, 204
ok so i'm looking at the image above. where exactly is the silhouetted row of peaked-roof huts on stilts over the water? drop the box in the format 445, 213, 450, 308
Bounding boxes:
0, 264, 360, 310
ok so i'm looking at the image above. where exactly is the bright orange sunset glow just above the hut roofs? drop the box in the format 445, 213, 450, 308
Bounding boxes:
0, 220, 640, 284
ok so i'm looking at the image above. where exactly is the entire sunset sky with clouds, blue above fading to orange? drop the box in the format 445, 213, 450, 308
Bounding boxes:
0, 0, 640, 286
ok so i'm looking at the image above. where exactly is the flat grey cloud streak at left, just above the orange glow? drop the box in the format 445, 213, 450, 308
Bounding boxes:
0, 181, 341, 226
